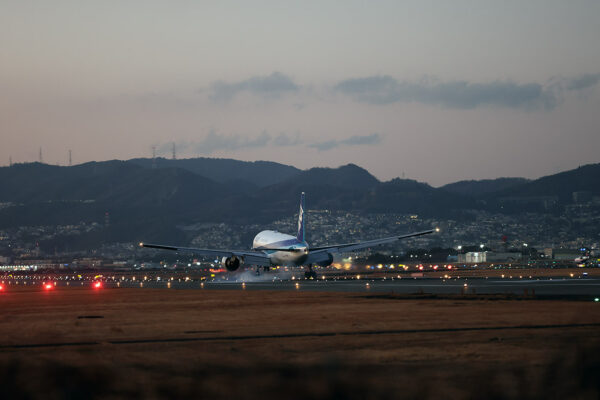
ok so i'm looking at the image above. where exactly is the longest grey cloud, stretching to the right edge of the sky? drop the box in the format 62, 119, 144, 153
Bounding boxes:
335, 74, 600, 109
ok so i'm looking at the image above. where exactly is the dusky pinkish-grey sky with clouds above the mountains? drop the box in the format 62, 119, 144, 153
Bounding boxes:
0, 0, 600, 186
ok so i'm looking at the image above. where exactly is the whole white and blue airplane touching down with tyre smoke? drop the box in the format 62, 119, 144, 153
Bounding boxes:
139, 192, 439, 279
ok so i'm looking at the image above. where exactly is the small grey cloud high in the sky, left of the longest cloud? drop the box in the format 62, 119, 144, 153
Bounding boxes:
210, 72, 300, 102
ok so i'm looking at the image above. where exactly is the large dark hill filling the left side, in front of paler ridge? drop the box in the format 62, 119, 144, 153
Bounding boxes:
0, 161, 239, 244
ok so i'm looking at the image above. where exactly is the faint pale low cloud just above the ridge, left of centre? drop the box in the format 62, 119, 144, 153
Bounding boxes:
158, 130, 302, 155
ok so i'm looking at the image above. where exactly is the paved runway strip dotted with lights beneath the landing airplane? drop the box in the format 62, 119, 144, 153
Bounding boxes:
2, 273, 600, 298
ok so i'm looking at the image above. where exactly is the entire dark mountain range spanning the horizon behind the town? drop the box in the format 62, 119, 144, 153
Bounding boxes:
0, 158, 600, 248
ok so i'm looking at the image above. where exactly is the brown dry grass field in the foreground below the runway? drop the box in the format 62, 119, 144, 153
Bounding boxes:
0, 287, 600, 399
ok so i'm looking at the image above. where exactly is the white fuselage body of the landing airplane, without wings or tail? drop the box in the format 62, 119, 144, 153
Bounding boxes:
252, 231, 308, 266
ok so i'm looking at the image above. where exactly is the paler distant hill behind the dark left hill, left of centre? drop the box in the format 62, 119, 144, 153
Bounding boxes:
128, 157, 301, 190
